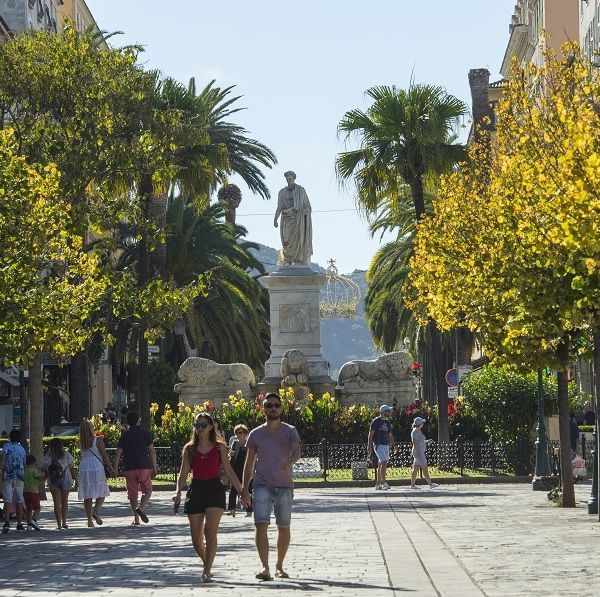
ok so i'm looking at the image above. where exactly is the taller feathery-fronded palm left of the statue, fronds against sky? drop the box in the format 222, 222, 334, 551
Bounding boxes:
105, 72, 276, 425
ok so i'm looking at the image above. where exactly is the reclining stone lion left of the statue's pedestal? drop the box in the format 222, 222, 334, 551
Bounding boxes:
176, 357, 256, 389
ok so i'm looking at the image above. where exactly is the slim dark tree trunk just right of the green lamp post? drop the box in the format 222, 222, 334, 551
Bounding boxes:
557, 341, 575, 508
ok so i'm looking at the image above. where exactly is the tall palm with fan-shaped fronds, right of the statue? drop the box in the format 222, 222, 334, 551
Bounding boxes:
336, 83, 467, 442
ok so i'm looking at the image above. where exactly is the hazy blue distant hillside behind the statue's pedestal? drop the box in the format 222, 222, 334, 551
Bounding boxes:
250, 245, 379, 379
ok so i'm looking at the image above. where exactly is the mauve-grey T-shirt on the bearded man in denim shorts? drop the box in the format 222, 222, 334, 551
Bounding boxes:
246, 423, 300, 487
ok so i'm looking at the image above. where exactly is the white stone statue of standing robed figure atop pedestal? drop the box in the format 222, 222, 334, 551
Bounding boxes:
274, 170, 312, 265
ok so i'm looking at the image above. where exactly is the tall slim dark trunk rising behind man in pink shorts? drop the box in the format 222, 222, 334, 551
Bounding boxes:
137, 174, 153, 429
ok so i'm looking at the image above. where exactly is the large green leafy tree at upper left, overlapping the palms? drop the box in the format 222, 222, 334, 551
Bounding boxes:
0, 27, 192, 420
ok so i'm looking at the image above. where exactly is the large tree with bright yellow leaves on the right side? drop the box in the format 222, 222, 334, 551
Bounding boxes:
409, 44, 600, 506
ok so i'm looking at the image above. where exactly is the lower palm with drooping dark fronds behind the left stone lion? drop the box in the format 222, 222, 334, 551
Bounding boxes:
113, 196, 270, 378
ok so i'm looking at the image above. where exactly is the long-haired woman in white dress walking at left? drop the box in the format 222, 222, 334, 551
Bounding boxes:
78, 419, 115, 527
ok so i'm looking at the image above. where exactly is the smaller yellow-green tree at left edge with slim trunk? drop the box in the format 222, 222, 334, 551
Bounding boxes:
0, 130, 110, 458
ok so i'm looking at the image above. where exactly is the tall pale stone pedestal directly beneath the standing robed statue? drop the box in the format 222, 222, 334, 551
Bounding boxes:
259, 266, 335, 393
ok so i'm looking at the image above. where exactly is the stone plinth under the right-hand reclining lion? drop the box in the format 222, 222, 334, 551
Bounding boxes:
335, 378, 417, 407
